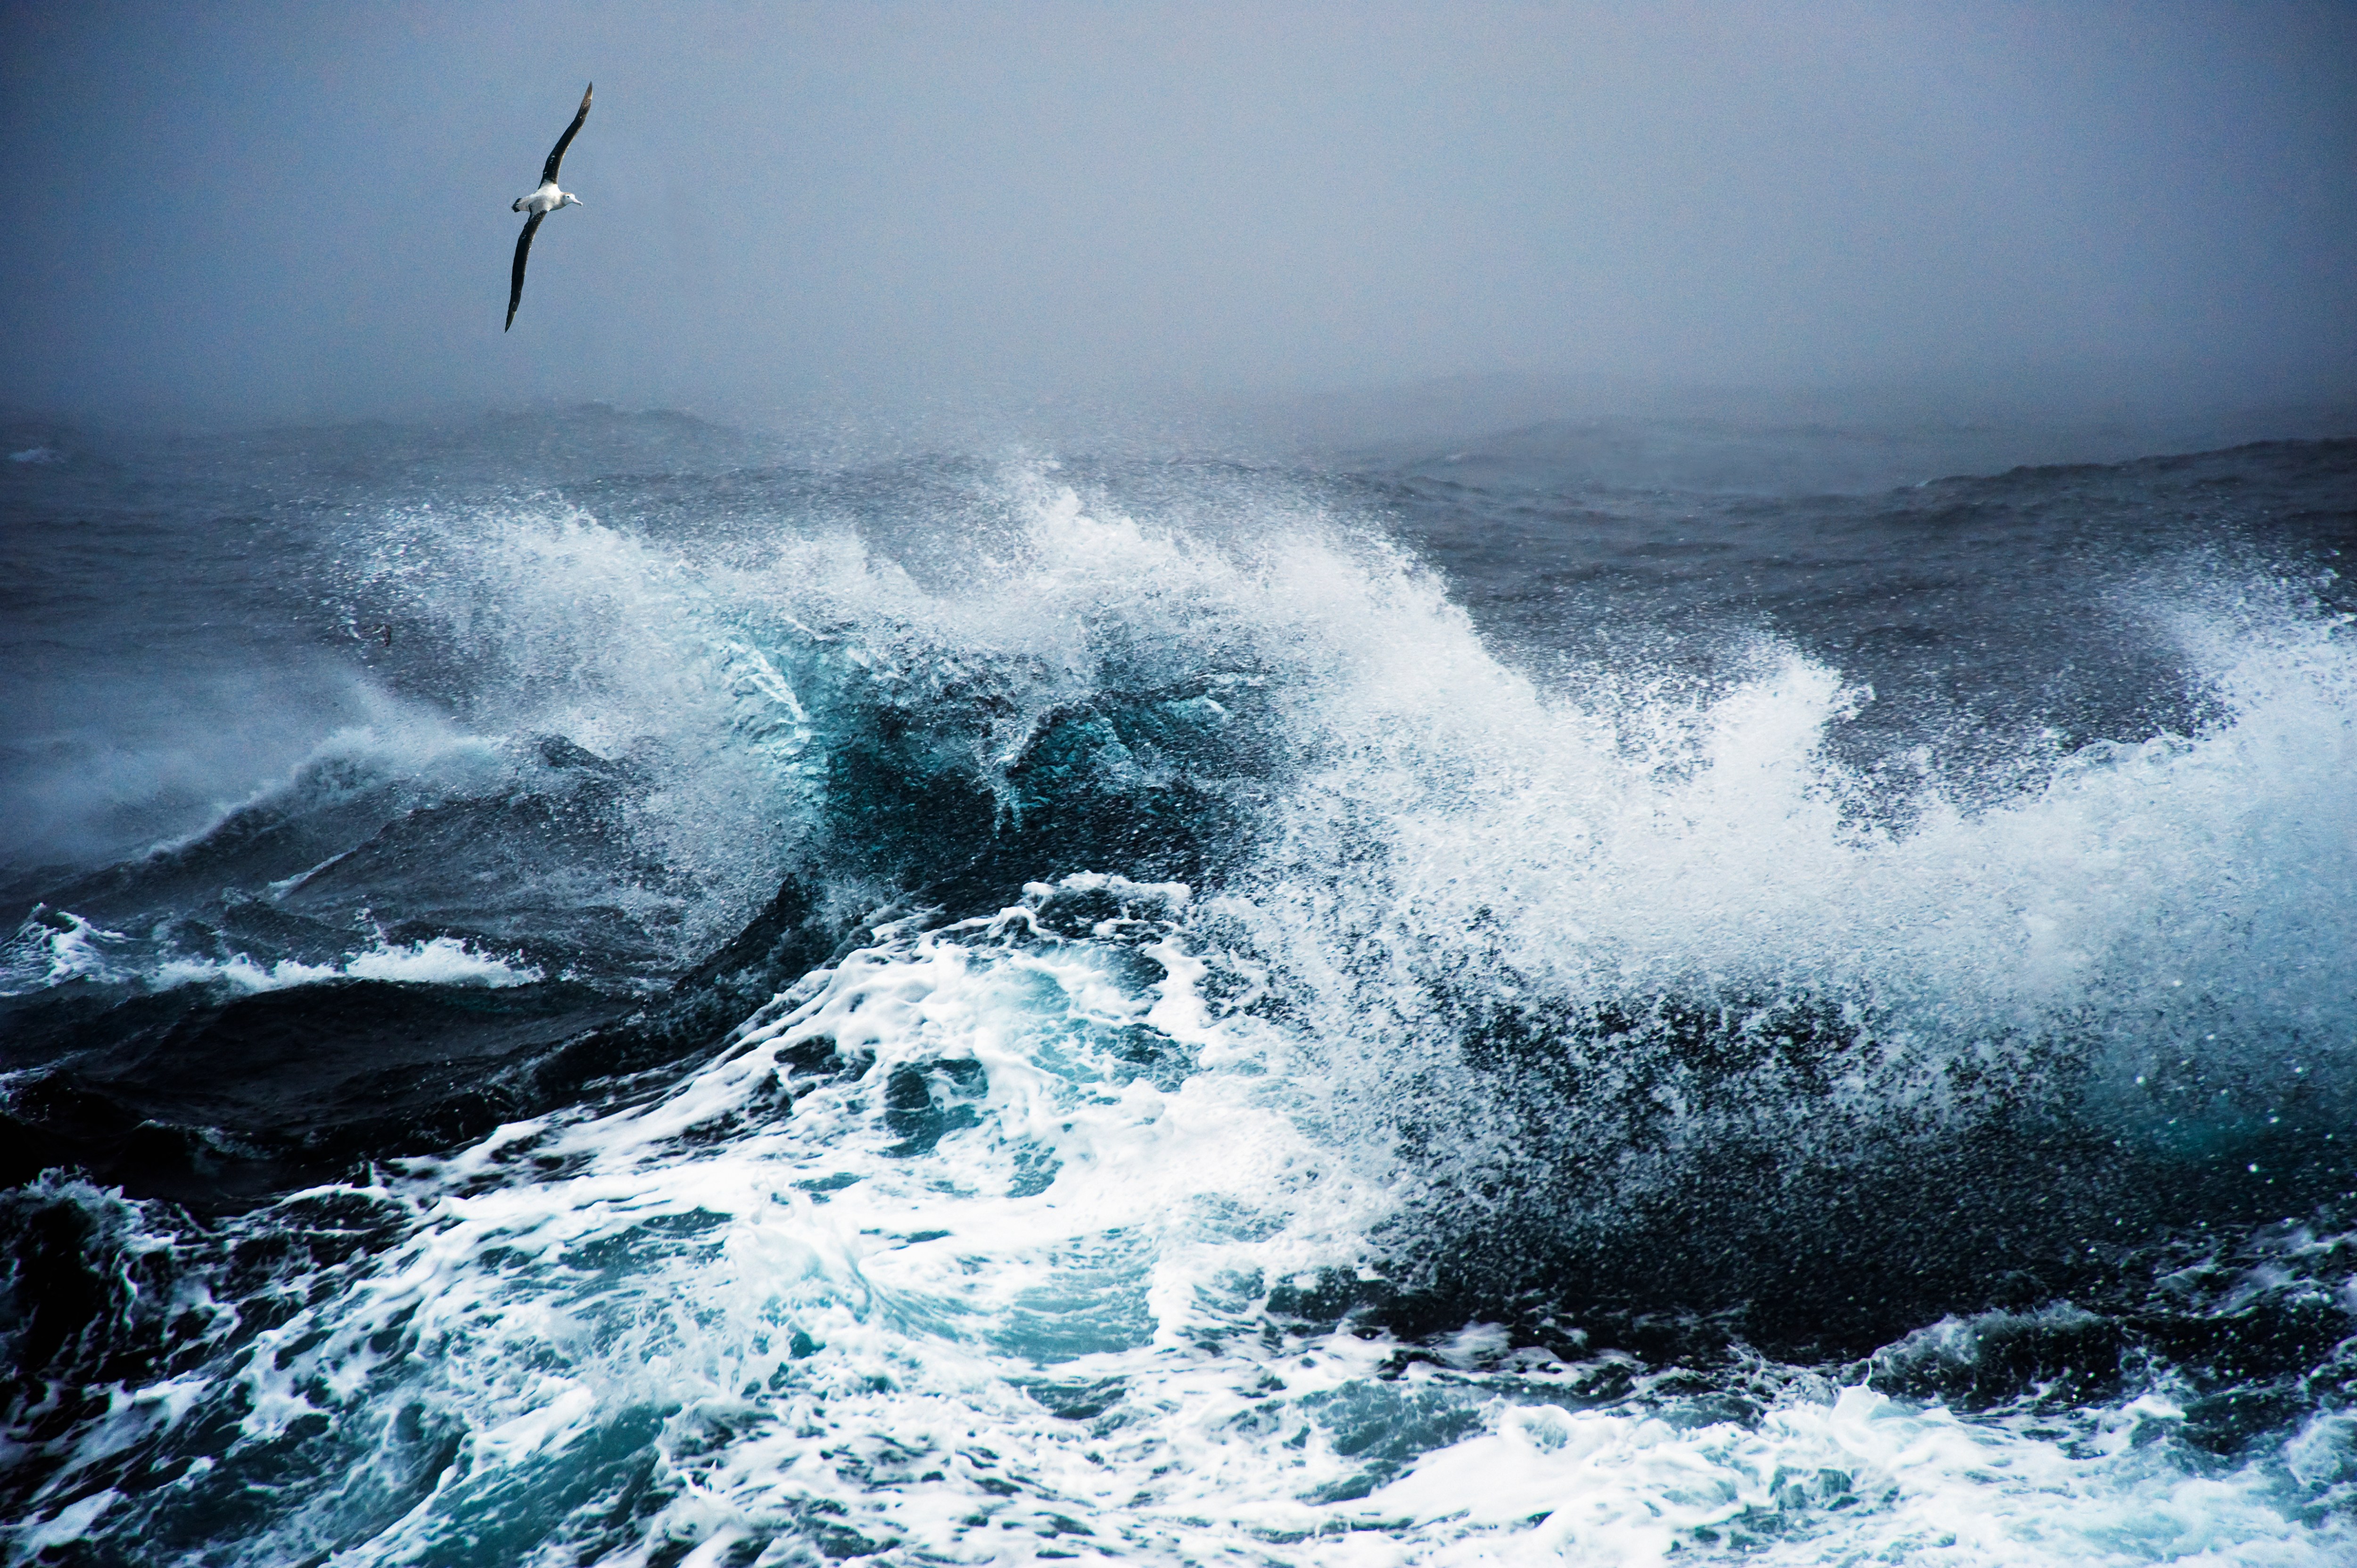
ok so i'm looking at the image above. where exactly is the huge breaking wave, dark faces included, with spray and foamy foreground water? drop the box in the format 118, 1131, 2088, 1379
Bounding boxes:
0, 446, 2357, 1566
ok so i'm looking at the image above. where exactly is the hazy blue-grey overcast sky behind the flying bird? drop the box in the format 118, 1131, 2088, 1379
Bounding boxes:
0, 0, 2357, 417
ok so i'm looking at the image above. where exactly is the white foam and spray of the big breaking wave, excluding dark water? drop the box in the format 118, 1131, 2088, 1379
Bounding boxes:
9, 460, 2357, 1566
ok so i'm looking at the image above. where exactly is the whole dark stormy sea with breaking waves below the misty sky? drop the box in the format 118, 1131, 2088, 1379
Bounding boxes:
0, 408, 2357, 1568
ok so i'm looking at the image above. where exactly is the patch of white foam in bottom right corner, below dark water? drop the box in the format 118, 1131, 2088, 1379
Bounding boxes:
1339, 1386, 2357, 1568
